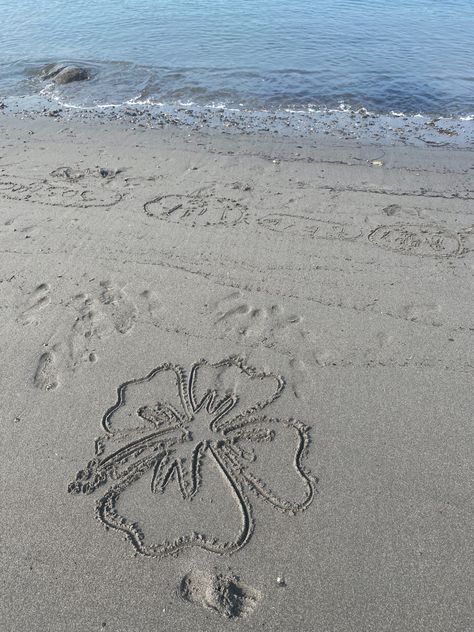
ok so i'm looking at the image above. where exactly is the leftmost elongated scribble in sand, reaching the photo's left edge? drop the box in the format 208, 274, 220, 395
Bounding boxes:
0, 176, 122, 208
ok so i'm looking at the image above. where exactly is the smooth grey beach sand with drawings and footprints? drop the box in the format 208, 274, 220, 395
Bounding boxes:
0, 114, 474, 632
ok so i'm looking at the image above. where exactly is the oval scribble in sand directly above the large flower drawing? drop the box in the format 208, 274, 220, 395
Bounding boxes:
144, 194, 247, 226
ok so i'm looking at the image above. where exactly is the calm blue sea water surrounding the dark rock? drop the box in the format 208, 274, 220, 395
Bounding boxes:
0, 0, 474, 116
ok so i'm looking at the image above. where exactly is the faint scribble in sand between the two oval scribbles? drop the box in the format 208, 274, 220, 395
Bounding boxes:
257, 213, 362, 240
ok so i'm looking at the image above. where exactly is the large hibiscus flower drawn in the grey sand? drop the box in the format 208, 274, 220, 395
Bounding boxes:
69, 357, 316, 557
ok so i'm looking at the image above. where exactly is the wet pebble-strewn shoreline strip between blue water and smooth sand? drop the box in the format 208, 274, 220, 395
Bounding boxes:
0, 96, 474, 149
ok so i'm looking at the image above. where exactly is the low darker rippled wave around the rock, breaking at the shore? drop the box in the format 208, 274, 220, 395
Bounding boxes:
0, 59, 474, 117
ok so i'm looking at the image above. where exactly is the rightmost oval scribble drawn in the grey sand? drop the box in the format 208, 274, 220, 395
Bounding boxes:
369, 224, 462, 257
